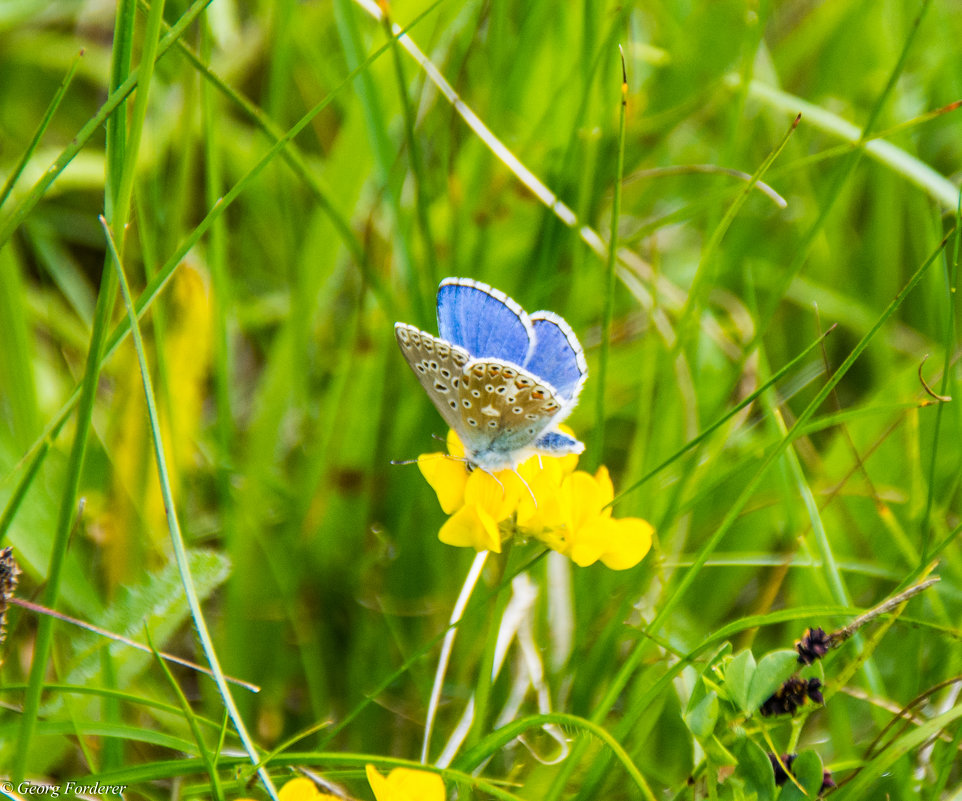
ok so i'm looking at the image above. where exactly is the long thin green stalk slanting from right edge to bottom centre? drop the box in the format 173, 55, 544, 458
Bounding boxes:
546, 229, 954, 801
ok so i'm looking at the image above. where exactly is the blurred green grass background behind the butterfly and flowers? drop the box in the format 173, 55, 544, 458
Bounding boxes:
0, 0, 962, 799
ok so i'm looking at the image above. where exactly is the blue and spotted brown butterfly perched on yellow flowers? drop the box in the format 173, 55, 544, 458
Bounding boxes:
394, 278, 588, 472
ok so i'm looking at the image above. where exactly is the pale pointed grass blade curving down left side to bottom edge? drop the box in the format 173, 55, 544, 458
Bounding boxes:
100, 217, 277, 801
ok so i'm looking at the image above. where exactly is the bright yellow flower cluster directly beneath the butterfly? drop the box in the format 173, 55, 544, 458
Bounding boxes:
418, 431, 653, 570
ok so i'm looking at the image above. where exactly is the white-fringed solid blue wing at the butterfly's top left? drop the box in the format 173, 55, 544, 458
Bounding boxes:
438, 278, 534, 365
